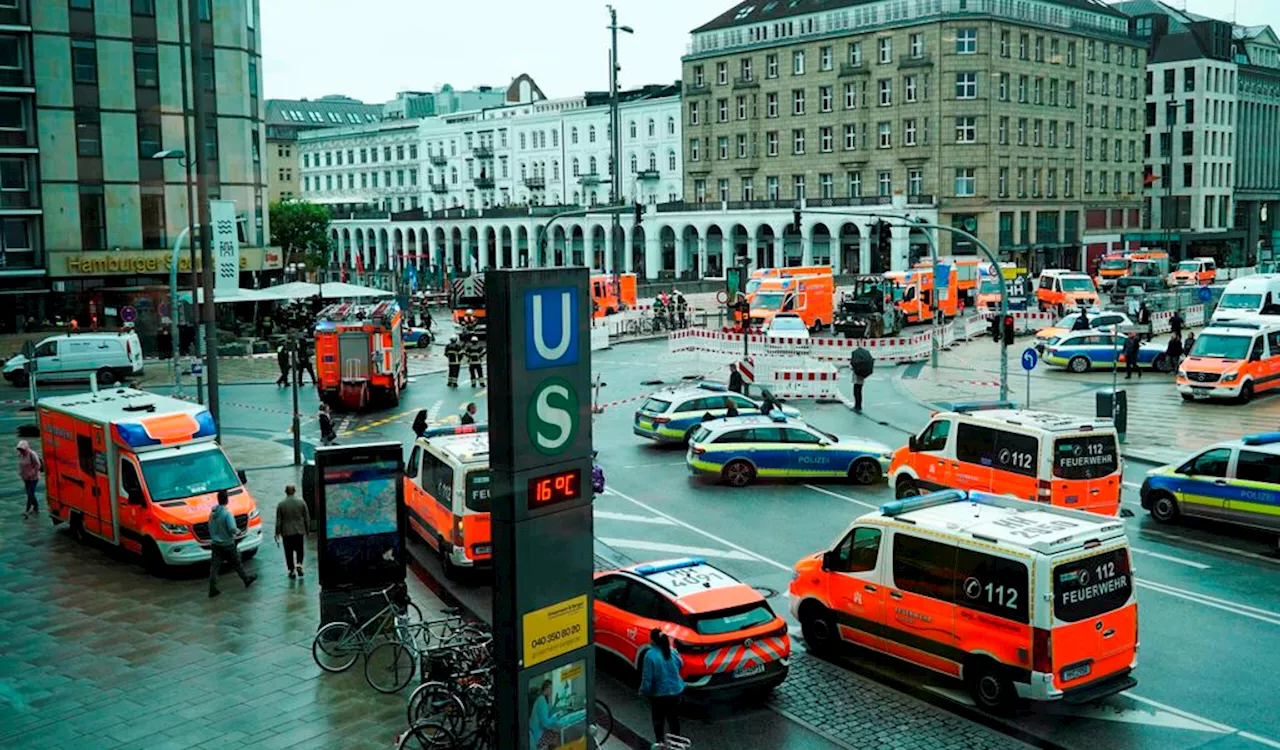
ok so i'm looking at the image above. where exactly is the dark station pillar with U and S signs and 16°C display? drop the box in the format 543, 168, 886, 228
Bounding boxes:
485, 267, 595, 750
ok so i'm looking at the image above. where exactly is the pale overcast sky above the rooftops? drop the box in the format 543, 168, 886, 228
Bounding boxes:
261, 0, 1280, 102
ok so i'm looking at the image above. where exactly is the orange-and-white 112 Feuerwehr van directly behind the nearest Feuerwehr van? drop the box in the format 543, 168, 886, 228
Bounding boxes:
890, 403, 1124, 516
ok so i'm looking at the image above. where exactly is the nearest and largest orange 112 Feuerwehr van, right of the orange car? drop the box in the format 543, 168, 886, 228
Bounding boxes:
791, 490, 1138, 713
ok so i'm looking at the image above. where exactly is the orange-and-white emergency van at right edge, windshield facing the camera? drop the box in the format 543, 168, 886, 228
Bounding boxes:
1178, 320, 1280, 403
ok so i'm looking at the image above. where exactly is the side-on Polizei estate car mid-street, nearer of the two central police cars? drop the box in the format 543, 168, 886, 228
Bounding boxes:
685, 415, 893, 486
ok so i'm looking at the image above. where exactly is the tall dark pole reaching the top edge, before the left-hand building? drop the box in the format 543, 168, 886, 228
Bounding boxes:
187, 0, 221, 434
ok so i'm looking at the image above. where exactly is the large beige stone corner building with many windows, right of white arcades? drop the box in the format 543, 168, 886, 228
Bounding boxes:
684, 0, 1146, 271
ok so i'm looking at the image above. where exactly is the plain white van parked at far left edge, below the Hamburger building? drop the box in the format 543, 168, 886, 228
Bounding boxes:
4, 331, 142, 385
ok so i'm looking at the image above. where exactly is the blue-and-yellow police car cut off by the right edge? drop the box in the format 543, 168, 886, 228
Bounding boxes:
1139, 433, 1280, 531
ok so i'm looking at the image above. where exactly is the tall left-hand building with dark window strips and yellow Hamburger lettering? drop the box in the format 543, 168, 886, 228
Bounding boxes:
0, 0, 270, 329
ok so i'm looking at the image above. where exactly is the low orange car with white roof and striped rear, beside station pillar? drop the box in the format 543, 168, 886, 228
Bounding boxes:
593, 558, 791, 695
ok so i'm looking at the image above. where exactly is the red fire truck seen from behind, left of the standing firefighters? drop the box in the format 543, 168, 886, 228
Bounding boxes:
315, 301, 408, 411
